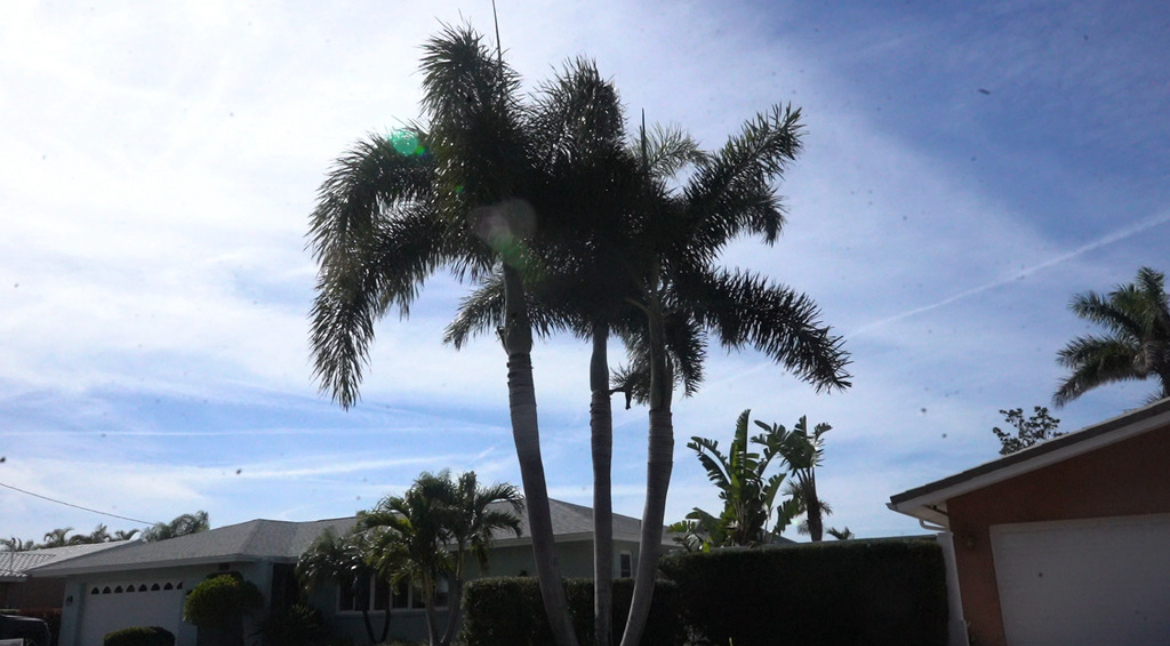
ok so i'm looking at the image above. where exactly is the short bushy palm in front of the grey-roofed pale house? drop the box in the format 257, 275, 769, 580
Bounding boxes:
357, 470, 519, 646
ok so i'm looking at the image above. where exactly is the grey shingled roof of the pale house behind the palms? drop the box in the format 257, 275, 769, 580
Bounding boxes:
30, 500, 641, 577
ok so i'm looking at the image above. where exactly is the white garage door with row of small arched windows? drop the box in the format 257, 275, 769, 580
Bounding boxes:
78, 580, 184, 646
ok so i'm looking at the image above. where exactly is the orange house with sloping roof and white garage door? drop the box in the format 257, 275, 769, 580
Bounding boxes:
889, 399, 1170, 646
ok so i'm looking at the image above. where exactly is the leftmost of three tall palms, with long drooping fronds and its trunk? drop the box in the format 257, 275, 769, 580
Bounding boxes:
310, 28, 641, 646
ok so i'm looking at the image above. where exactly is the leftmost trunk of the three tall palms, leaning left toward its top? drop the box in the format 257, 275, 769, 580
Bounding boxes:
503, 264, 577, 646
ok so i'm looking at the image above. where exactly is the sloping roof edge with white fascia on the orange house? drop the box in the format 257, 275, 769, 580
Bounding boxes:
888, 399, 1170, 527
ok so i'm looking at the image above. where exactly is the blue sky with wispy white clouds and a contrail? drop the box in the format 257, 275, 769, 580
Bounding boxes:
0, 0, 1170, 540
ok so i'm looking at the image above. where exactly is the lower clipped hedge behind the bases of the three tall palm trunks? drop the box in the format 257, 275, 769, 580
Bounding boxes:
463, 577, 683, 646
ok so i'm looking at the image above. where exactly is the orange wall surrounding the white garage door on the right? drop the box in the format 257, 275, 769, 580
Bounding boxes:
947, 426, 1170, 646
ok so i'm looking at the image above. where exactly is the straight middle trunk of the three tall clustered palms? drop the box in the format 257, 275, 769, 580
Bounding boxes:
590, 323, 613, 646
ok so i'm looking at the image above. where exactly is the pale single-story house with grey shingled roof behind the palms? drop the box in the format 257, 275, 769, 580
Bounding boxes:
30, 501, 659, 646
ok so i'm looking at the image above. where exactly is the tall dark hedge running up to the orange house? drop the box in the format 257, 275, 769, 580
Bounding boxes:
661, 538, 947, 646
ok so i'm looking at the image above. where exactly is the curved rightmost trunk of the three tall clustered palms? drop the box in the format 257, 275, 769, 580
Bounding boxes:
621, 294, 674, 646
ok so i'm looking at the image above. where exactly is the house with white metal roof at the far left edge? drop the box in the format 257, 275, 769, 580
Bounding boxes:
0, 541, 126, 611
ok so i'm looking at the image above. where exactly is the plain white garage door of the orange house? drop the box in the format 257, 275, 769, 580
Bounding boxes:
991, 515, 1170, 646
